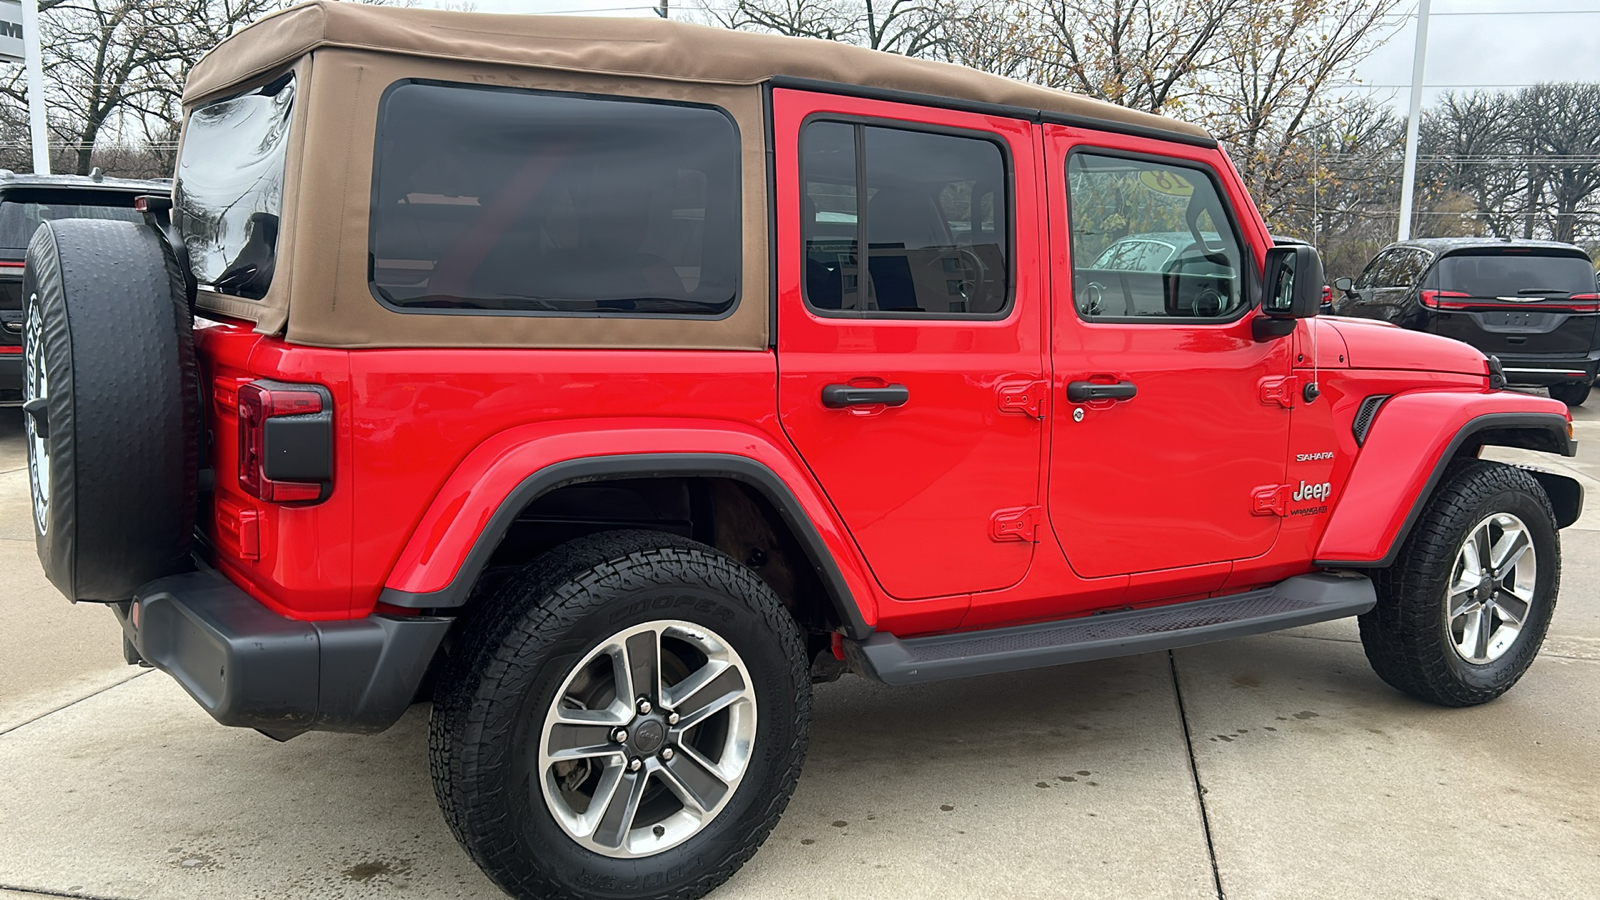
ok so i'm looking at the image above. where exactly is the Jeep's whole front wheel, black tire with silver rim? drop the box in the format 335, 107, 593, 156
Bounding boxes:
1360, 460, 1562, 706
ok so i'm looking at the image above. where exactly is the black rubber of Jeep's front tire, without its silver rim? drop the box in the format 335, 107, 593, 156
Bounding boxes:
1360, 460, 1562, 706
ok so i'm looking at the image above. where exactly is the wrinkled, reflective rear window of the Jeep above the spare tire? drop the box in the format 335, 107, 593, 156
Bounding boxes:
173, 75, 294, 299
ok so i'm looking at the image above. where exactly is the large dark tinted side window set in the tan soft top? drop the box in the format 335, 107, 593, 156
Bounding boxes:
368, 82, 744, 315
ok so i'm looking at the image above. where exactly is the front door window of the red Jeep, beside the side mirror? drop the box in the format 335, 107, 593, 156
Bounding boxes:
1067, 152, 1250, 322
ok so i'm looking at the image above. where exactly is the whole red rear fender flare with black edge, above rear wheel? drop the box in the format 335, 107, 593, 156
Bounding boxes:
378, 423, 877, 639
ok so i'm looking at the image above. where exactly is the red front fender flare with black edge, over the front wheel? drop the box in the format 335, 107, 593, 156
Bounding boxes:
1315, 391, 1582, 569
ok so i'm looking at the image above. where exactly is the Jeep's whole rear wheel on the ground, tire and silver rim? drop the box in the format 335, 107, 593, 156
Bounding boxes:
430, 532, 811, 900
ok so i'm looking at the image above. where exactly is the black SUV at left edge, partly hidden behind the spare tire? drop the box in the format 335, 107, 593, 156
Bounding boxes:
0, 168, 173, 407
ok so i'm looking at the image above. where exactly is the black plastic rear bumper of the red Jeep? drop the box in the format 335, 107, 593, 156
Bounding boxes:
114, 572, 451, 740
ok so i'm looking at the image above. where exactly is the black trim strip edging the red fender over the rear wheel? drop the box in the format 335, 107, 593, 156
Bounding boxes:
378, 453, 872, 641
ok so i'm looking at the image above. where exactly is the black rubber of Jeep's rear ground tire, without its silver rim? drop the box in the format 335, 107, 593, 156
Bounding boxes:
429, 530, 811, 900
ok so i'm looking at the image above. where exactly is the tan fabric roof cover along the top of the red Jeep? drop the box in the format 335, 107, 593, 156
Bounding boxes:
184, 0, 1210, 139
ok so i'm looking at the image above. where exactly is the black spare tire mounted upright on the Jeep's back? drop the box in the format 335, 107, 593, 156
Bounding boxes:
22, 219, 200, 601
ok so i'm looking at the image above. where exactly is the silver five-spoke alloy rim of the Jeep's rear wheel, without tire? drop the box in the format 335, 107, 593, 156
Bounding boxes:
538, 620, 755, 858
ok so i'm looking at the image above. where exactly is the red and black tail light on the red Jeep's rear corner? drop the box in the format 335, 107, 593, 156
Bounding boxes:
238, 381, 333, 503
